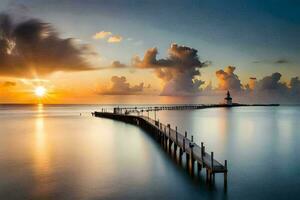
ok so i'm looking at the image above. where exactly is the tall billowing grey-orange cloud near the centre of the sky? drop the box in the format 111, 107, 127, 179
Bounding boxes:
132, 44, 205, 96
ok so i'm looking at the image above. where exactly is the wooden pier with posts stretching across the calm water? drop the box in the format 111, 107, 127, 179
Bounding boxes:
93, 112, 228, 189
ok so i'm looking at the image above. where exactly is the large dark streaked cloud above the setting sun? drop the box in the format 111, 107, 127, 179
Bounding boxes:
0, 14, 97, 78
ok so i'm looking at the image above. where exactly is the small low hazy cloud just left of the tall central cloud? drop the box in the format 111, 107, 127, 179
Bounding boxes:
98, 76, 145, 95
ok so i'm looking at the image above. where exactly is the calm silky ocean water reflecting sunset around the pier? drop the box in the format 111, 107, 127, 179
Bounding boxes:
0, 105, 300, 199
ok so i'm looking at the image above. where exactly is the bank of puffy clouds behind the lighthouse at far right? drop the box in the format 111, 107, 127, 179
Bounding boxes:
211, 66, 300, 103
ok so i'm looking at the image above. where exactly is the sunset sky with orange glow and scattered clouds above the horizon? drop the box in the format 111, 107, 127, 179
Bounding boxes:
0, 0, 300, 103
